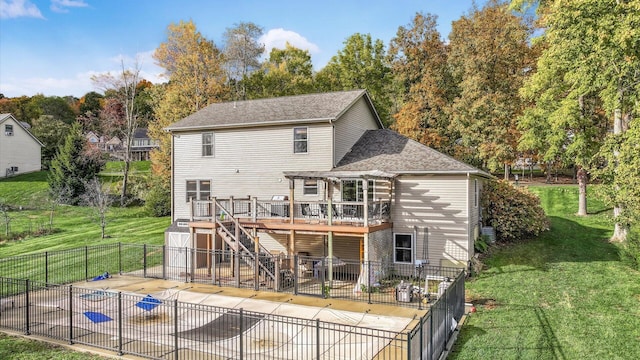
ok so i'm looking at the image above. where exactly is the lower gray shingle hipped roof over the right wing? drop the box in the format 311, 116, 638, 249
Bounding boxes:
333, 129, 491, 177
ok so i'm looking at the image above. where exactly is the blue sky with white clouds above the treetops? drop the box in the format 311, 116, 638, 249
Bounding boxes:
0, 0, 485, 98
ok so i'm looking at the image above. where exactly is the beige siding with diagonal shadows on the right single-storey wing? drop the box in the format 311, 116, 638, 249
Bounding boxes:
392, 175, 469, 265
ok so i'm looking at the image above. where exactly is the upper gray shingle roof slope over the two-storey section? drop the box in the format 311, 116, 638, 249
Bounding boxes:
167, 90, 379, 131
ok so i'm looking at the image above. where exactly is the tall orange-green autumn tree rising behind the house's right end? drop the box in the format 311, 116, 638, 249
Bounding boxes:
449, 0, 532, 178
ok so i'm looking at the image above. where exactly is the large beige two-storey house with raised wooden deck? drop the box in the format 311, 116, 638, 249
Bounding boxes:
166, 90, 490, 282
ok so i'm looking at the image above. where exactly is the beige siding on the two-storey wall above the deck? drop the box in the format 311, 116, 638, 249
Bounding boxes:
173, 123, 332, 219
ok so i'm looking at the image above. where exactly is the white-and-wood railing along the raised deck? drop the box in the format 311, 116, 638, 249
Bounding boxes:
191, 198, 391, 225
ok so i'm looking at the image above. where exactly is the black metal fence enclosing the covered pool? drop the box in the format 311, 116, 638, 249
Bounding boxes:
0, 243, 464, 359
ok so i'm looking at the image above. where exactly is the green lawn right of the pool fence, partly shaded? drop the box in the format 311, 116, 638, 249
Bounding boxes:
450, 186, 640, 359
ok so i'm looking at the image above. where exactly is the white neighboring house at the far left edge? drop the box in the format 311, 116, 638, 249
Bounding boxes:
0, 114, 44, 177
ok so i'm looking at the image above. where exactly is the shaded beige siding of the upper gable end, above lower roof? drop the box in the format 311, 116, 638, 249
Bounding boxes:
333, 97, 378, 164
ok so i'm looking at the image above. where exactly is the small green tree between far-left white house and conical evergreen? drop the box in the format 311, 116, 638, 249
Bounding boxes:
31, 115, 71, 168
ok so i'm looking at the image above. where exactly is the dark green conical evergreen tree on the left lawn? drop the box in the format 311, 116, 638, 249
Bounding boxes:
48, 124, 104, 205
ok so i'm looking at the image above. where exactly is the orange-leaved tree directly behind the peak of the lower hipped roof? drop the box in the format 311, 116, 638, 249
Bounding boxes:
389, 13, 457, 154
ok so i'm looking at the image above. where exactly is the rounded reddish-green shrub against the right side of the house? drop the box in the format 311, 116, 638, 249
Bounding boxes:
481, 180, 549, 242
